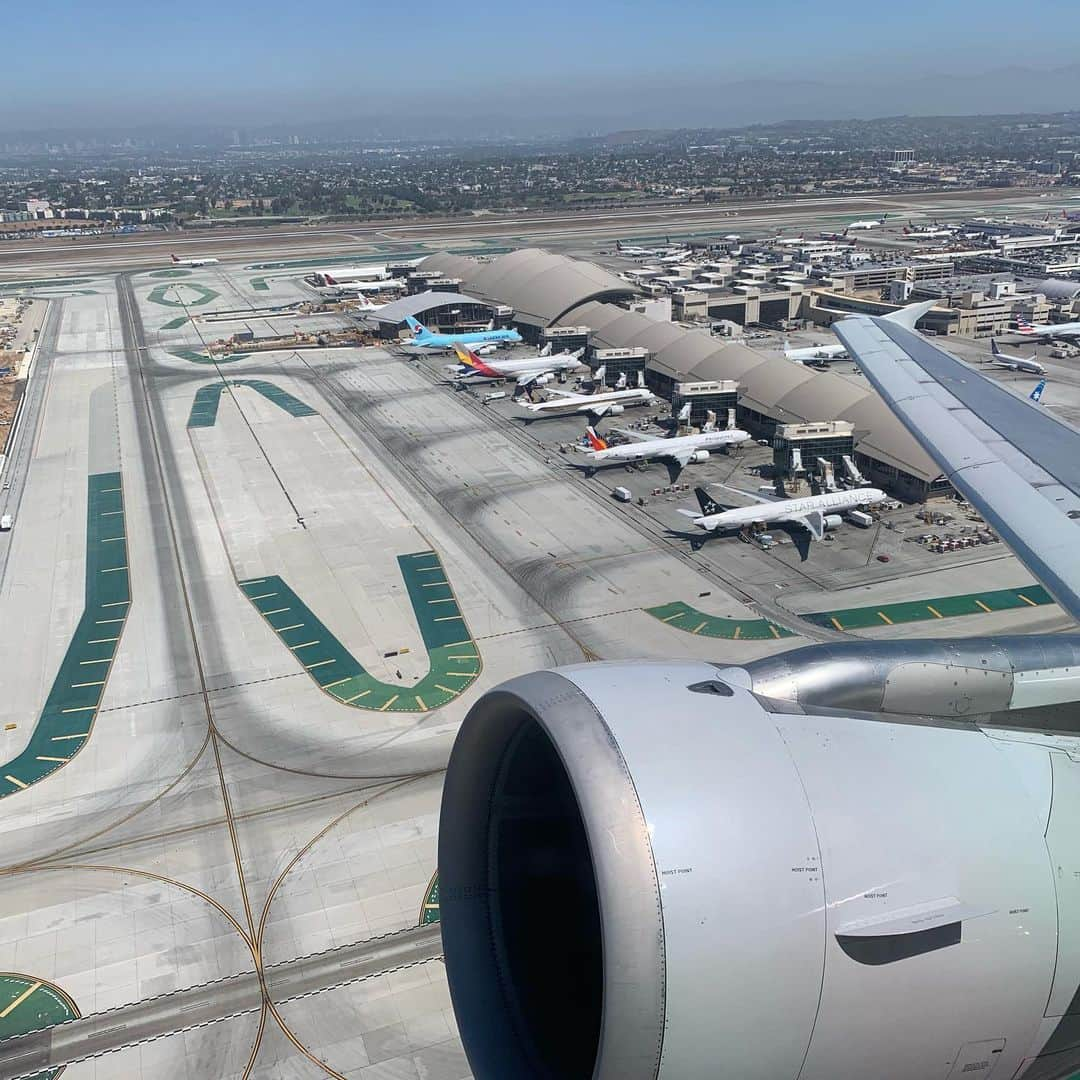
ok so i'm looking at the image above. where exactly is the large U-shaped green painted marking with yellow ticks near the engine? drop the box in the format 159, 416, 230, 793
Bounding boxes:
240, 551, 482, 713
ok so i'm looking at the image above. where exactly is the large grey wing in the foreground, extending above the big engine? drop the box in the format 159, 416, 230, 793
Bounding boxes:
833, 315, 1080, 619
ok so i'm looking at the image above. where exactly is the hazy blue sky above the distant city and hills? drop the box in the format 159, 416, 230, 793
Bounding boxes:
6, 0, 1080, 131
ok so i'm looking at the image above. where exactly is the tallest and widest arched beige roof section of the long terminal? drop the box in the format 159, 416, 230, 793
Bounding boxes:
419, 247, 639, 326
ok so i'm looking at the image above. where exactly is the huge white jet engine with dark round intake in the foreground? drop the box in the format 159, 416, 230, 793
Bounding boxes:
438, 639, 1080, 1080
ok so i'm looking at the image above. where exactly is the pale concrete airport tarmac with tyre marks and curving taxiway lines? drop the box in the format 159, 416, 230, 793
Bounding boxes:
0, 232, 1080, 1080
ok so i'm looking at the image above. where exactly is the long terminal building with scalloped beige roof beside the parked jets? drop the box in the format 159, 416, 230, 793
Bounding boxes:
421, 248, 950, 501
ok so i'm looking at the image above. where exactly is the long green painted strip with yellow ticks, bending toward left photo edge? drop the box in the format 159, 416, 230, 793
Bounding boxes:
0, 473, 131, 803
